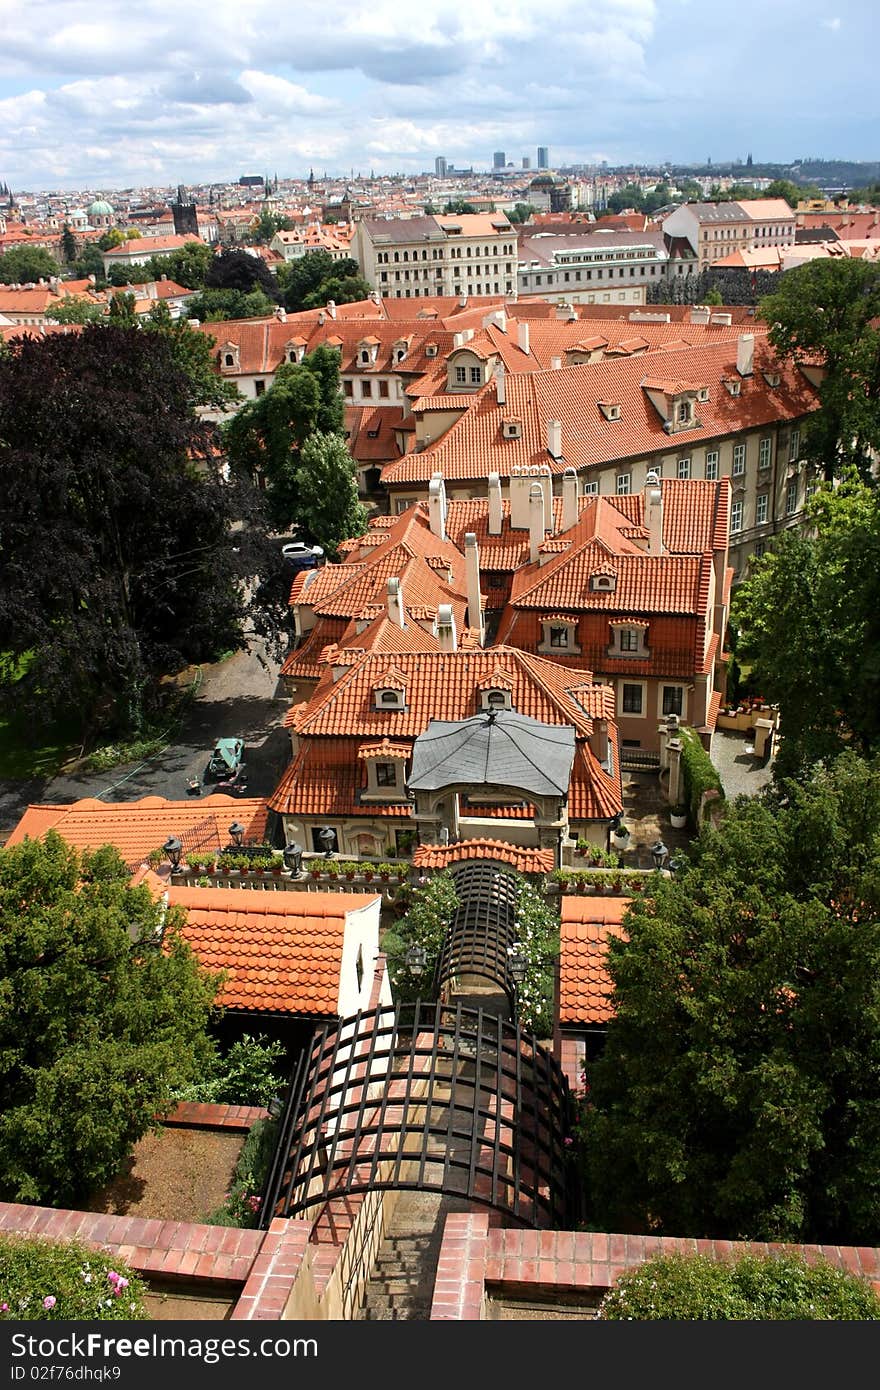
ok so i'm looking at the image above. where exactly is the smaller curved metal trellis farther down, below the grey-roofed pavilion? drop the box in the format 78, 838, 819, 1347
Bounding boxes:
435, 860, 517, 1005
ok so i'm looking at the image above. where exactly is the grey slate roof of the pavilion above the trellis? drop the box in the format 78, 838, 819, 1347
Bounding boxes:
407, 709, 574, 796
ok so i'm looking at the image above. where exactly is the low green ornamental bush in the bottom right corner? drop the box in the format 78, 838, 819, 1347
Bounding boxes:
599, 1254, 880, 1322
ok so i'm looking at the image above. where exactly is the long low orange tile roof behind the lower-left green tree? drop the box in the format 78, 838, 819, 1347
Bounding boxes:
7, 792, 268, 865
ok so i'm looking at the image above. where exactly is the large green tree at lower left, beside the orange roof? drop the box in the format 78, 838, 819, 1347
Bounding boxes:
0, 831, 218, 1205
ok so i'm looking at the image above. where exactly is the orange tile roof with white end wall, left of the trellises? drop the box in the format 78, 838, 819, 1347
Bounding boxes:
168, 887, 375, 1016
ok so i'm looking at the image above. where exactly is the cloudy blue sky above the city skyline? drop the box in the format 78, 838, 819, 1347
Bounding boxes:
0, 0, 880, 192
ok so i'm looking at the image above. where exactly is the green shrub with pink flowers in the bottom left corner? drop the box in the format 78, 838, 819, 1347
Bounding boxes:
0, 1234, 149, 1322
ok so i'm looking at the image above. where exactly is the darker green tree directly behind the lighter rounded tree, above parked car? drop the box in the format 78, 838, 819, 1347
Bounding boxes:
224, 345, 345, 530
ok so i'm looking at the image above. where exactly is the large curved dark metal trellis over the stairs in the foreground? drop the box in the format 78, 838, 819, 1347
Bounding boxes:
261, 1004, 571, 1227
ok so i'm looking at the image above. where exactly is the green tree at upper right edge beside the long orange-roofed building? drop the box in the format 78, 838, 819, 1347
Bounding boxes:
758, 257, 880, 478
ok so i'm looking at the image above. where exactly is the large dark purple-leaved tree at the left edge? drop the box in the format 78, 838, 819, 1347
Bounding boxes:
0, 325, 277, 734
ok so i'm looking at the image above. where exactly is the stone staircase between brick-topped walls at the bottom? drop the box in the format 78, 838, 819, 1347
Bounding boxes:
357, 1193, 470, 1322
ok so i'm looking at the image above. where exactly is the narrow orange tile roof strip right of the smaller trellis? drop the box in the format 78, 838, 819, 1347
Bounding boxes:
557, 895, 630, 1026
